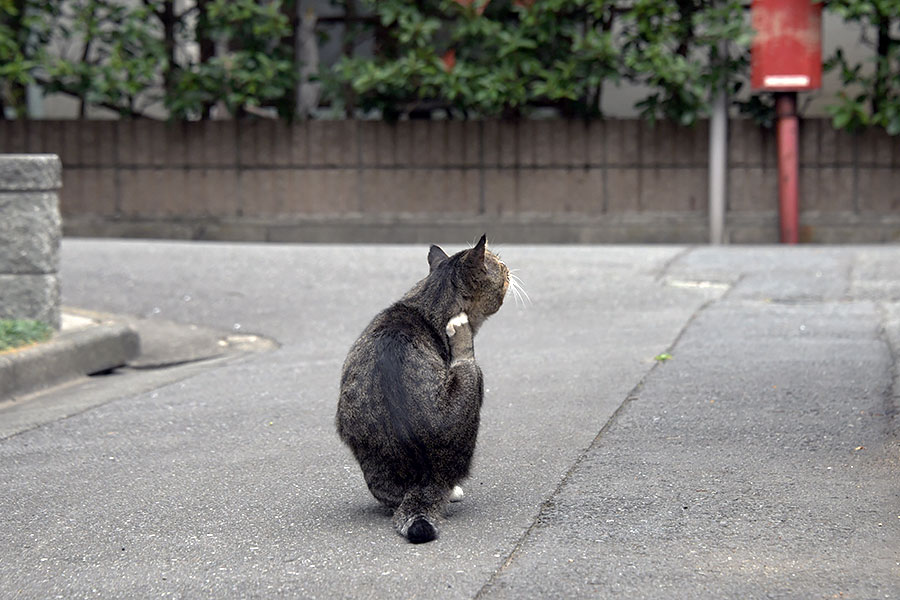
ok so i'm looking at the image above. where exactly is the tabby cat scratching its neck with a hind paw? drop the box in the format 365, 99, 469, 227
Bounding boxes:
336, 236, 510, 543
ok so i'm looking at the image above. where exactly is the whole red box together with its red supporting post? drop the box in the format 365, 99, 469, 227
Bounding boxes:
750, 0, 822, 244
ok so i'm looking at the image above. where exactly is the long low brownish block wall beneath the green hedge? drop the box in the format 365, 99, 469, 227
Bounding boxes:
0, 119, 900, 243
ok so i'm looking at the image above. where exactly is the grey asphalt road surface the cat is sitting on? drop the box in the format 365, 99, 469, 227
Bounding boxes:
0, 240, 900, 598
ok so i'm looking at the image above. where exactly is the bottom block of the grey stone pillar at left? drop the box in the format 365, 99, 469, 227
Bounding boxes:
0, 273, 59, 328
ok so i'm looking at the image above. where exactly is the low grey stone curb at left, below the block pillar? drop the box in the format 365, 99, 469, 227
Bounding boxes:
0, 322, 140, 401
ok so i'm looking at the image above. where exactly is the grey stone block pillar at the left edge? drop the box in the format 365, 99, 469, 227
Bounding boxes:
0, 154, 61, 328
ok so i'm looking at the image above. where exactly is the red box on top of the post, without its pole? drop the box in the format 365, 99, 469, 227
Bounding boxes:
750, 0, 822, 92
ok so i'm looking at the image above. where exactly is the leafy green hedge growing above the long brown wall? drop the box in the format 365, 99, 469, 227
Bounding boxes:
0, 0, 900, 134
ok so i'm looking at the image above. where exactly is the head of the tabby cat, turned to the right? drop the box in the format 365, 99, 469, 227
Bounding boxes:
428, 235, 509, 317
